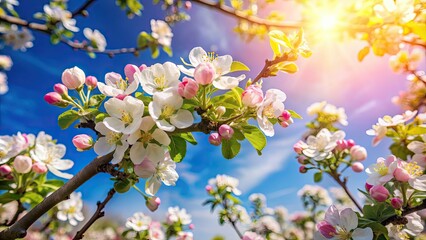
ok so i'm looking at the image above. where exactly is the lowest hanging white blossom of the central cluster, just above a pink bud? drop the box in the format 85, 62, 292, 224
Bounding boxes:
145, 153, 179, 196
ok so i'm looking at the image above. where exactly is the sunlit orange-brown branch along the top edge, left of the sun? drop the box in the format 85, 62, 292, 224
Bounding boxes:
192, 0, 302, 29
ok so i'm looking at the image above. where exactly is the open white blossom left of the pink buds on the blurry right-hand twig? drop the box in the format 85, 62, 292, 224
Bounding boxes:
302, 128, 345, 161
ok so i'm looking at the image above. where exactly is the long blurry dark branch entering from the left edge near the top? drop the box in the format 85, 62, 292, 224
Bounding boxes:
0, 15, 148, 57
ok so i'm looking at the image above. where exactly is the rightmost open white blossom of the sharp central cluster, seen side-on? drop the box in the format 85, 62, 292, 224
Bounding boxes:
257, 89, 287, 137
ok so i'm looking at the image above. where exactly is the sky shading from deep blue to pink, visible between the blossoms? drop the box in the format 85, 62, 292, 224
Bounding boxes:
0, 1, 424, 239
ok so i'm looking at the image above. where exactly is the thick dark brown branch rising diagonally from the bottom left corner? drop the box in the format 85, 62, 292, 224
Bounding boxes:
0, 153, 113, 240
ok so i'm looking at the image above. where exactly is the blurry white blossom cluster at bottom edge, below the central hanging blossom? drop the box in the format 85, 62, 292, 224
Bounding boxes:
122, 207, 194, 240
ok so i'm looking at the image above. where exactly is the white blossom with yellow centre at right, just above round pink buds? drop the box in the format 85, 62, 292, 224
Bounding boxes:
365, 155, 398, 186
